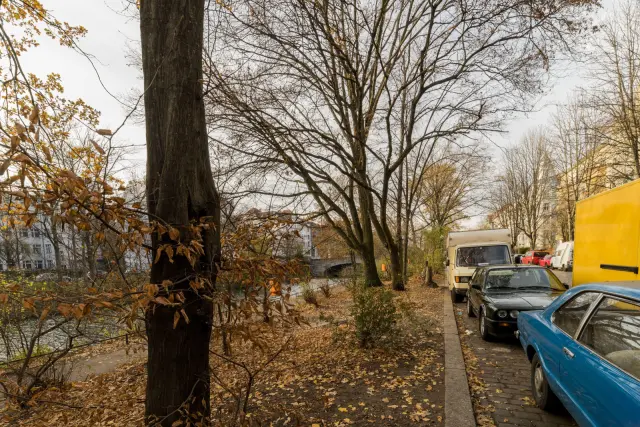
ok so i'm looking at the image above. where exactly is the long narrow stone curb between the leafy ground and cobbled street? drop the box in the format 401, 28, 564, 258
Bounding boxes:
444, 289, 476, 427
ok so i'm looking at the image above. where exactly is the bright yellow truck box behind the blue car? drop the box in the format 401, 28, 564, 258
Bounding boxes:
573, 179, 640, 286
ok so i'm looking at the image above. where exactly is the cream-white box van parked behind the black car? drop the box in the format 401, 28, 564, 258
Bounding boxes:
445, 228, 513, 302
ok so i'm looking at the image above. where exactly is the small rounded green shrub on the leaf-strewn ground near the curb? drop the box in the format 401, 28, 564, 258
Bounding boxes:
351, 284, 398, 348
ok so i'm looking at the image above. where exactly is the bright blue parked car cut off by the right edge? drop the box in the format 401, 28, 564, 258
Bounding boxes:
516, 283, 640, 427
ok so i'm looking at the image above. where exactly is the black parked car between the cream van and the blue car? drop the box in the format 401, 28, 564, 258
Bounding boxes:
467, 265, 567, 340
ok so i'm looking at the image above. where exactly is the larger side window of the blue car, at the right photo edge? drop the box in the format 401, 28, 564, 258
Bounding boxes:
579, 297, 640, 378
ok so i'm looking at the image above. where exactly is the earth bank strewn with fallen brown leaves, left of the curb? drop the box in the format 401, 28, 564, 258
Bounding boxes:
0, 283, 444, 427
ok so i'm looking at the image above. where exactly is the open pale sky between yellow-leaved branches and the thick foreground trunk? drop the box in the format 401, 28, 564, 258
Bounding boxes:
22, 0, 145, 170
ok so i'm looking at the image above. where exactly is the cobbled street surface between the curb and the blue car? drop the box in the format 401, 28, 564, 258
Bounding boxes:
454, 300, 576, 427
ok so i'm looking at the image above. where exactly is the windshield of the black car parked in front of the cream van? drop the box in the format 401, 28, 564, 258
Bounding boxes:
484, 268, 564, 291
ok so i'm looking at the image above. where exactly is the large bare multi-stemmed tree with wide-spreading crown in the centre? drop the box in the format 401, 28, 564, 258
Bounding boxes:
206, 0, 591, 289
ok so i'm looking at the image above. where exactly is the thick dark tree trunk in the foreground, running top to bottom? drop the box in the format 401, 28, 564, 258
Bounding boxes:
140, 0, 220, 426
